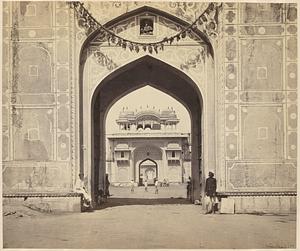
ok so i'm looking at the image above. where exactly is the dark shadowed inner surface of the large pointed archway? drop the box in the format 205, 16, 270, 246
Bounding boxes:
91, 56, 203, 204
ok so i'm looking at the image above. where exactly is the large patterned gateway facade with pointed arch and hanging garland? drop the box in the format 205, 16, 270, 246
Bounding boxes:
2, 1, 298, 212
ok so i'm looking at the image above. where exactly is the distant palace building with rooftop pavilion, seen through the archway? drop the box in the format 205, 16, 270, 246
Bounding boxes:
106, 108, 191, 185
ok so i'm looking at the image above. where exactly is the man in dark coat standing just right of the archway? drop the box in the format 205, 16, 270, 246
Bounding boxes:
205, 172, 217, 214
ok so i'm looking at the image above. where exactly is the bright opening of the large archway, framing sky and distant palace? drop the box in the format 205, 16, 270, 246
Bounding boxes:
105, 85, 191, 193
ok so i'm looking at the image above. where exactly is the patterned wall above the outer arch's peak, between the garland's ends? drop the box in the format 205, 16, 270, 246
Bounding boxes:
84, 1, 209, 24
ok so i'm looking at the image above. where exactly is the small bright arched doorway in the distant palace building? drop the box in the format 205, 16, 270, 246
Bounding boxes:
139, 158, 158, 186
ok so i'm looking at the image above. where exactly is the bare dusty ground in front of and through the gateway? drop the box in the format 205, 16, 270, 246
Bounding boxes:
3, 186, 296, 249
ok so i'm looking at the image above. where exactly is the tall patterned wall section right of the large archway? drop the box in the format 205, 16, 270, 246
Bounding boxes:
223, 3, 297, 191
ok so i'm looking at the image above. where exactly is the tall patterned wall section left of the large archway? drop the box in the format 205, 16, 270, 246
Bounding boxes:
2, 2, 75, 191
